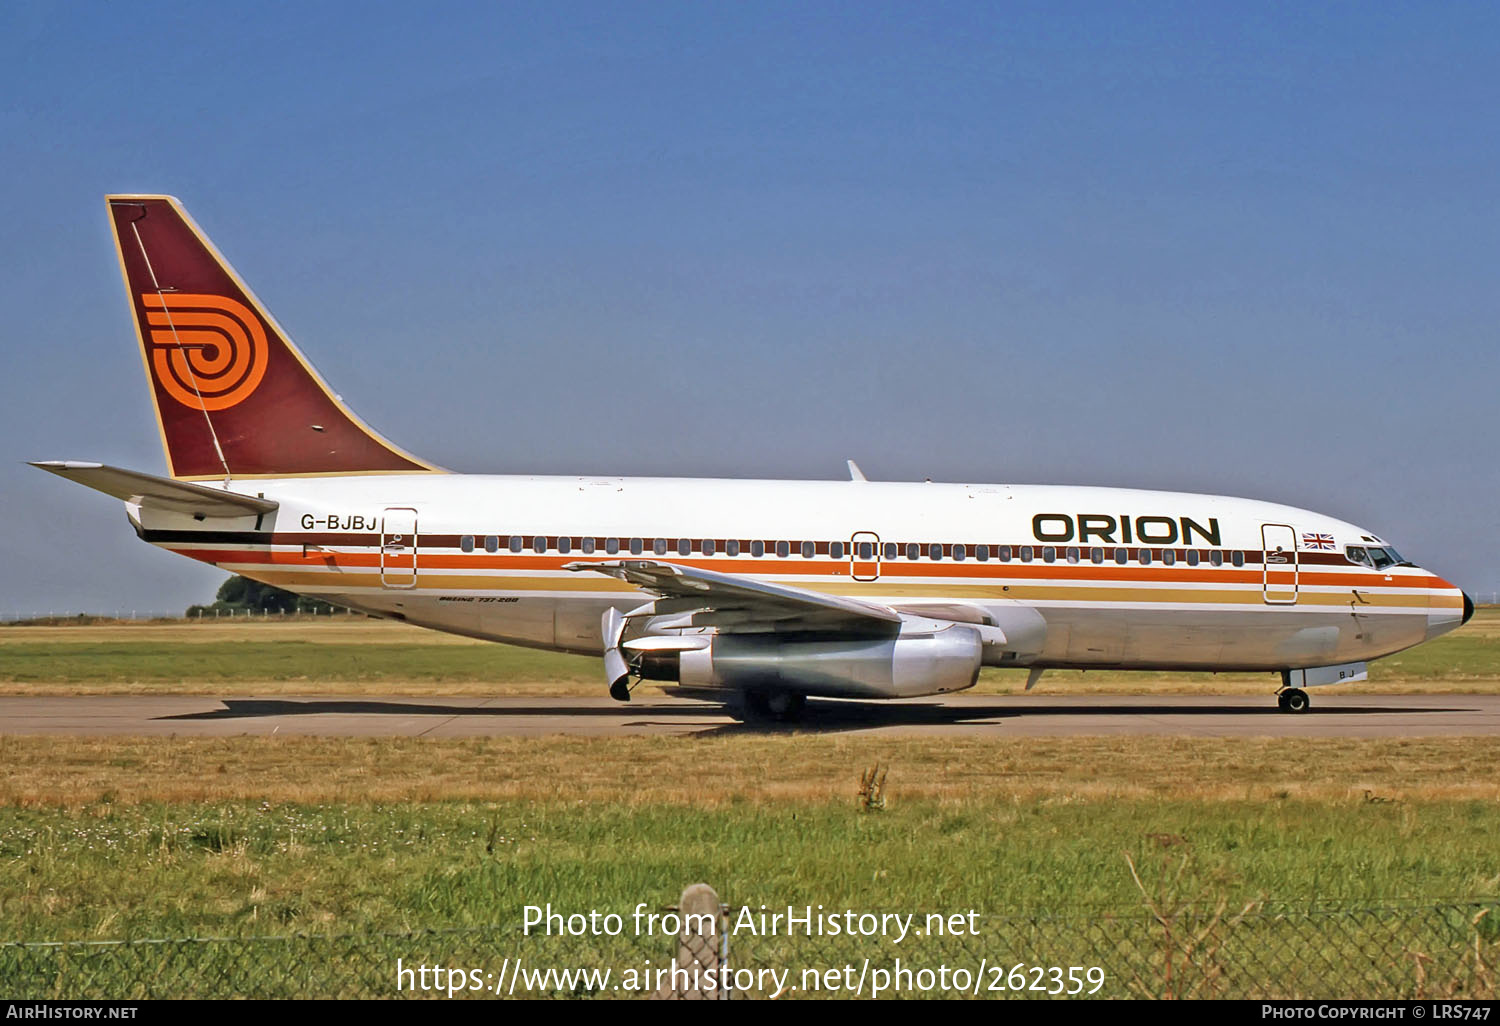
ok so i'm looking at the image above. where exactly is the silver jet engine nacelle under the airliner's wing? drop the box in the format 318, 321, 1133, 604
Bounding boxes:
641, 626, 983, 698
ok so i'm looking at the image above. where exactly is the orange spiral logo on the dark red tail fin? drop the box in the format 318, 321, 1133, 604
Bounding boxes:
141, 293, 270, 410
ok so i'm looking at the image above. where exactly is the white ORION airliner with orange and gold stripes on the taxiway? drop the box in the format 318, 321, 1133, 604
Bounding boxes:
36, 195, 1473, 717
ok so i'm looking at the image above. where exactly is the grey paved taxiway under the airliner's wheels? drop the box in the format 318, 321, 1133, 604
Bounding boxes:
0, 693, 1500, 738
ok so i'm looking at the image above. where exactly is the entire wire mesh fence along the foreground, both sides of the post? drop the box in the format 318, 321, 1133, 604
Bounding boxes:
0, 900, 1500, 999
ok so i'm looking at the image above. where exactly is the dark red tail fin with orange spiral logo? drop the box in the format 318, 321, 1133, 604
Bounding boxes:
108, 197, 440, 479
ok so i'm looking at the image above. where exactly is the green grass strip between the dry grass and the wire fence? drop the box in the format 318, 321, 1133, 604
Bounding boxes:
0, 797, 1500, 939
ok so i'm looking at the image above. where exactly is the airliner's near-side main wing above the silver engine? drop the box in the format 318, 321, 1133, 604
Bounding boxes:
566, 560, 902, 632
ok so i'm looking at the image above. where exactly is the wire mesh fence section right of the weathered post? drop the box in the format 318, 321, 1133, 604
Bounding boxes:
731, 902, 1500, 999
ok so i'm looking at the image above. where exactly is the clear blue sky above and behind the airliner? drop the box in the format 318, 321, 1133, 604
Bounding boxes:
0, 3, 1500, 612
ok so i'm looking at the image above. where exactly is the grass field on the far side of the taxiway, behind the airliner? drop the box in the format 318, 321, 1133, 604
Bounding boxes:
0, 609, 1500, 695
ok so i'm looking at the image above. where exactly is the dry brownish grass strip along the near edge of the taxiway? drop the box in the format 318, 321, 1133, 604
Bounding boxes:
0, 732, 1500, 809
